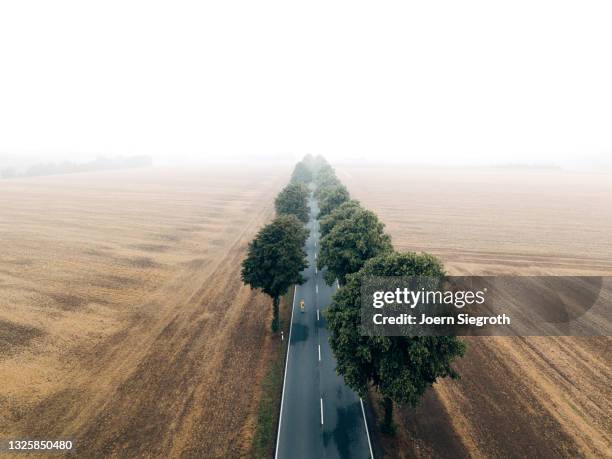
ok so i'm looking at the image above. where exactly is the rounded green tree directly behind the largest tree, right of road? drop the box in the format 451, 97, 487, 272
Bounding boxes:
318, 209, 393, 284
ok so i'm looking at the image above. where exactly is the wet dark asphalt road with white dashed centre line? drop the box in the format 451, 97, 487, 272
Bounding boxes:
276, 200, 372, 459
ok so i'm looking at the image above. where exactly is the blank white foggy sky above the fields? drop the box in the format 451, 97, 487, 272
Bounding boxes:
0, 0, 612, 164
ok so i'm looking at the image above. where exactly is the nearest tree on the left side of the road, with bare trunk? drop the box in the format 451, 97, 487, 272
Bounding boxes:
241, 215, 308, 332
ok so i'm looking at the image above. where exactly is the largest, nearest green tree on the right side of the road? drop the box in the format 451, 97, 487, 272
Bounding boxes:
326, 252, 465, 432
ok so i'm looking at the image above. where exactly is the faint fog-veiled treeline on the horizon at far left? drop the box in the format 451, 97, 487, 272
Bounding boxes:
0, 156, 153, 179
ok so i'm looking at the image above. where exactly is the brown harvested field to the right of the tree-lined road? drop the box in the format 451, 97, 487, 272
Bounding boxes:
337, 166, 612, 457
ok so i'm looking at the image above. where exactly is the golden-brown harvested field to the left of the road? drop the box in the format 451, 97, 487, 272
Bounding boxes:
0, 164, 290, 457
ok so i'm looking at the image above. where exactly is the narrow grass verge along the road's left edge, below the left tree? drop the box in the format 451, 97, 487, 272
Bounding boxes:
251, 286, 295, 459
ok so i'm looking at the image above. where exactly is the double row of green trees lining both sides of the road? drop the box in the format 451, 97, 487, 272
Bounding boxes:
242, 155, 465, 433
